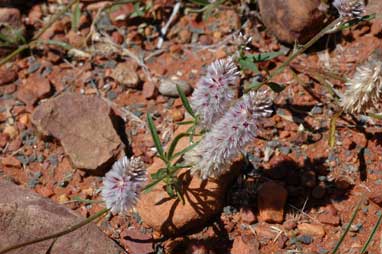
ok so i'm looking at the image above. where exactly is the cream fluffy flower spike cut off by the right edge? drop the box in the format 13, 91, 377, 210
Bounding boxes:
341, 50, 382, 113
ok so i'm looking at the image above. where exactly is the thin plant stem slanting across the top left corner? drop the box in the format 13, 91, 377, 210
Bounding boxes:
0, 0, 79, 66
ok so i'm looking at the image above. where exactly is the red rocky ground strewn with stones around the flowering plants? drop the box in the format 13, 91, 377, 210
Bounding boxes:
0, 0, 382, 254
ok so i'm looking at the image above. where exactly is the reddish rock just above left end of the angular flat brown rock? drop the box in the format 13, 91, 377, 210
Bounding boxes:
16, 73, 51, 105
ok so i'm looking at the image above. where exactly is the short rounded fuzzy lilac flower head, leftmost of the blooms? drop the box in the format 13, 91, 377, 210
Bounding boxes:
101, 156, 146, 213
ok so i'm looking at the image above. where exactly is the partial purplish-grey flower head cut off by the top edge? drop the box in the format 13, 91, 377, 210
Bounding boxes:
333, 0, 365, 19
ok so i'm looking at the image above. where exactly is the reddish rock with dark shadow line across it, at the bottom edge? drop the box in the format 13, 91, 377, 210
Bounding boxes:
121, 229, 154, 254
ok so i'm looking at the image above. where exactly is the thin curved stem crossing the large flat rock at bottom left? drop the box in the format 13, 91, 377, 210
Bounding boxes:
0, 208, 110, 254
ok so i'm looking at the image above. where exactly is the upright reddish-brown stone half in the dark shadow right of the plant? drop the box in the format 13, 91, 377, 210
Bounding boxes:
257, 182, 288, 223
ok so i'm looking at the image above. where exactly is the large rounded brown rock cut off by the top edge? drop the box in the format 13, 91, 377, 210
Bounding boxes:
258, 0, 326, 44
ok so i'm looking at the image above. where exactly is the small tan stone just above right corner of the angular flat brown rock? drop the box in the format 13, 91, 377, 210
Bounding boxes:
110, 62, 140, 88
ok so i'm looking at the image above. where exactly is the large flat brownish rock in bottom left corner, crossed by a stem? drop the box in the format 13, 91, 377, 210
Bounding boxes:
0, 179, 125, 254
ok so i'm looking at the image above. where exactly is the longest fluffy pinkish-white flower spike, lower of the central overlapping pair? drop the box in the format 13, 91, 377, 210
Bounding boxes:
185, 91, 272, 179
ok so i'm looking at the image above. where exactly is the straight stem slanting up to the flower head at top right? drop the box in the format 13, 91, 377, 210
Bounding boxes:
245, 18, 341, 92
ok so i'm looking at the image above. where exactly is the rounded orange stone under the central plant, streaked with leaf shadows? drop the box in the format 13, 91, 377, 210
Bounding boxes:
137, 122, 243, 235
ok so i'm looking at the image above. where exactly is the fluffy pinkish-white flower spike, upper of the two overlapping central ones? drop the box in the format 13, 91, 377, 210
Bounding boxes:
191, 57, 239, 129
